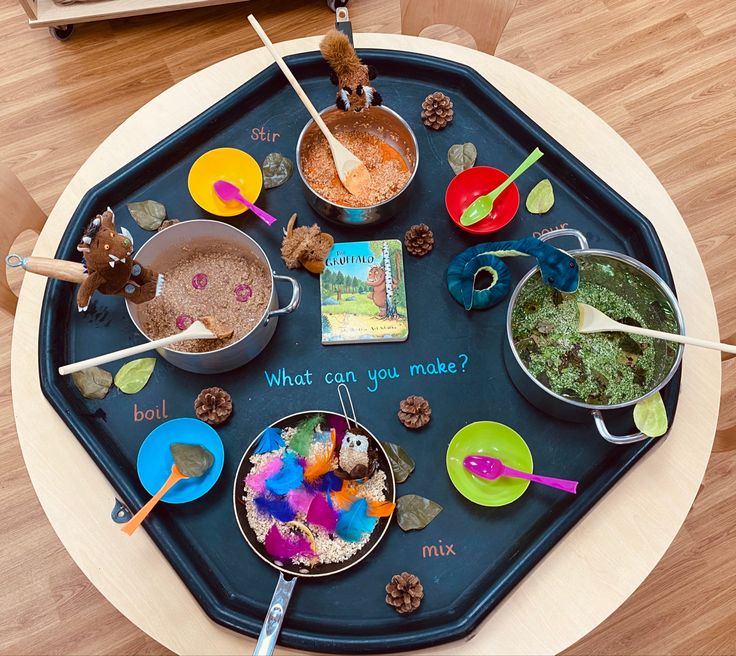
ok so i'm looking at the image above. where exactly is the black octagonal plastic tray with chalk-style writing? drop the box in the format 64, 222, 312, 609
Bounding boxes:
39, 50, 679, 653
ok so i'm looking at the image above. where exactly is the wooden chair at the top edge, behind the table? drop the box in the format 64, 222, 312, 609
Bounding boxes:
401, 0, 518, 55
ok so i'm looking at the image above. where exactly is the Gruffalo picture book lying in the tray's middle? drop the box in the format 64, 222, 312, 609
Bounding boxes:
320, 239, 409, 344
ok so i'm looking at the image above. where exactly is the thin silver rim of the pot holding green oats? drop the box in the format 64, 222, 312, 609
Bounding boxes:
506, 248, 685, 411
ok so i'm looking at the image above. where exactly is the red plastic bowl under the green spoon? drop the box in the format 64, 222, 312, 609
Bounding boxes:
445, 166, 519, 235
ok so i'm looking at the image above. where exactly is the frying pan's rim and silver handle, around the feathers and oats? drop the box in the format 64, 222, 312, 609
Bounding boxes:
233, 404, 396, 656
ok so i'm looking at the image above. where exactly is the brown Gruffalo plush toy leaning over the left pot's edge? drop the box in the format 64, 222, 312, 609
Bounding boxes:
77, 207, 158, 312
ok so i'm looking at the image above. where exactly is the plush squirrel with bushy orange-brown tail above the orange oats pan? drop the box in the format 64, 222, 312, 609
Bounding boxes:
319, 29, 383, 112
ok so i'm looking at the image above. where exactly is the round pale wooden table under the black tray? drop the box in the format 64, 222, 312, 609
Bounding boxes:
11, 34, 720, 654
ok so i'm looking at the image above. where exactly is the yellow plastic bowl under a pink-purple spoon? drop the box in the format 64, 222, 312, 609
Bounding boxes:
187, 148, 263, 216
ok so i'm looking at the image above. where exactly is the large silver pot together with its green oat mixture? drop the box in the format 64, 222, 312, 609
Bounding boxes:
504, 230, 684, 444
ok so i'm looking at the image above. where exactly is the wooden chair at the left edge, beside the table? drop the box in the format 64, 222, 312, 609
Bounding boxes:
0, 162, 46, 315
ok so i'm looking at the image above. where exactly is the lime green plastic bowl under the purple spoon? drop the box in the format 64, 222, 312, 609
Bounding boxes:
445, 421, 534, 506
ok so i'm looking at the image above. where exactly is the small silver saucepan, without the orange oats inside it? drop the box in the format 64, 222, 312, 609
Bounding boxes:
296, 105, 419, 225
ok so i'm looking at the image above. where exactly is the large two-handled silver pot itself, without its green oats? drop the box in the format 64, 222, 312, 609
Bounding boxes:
504, 229, 685, 444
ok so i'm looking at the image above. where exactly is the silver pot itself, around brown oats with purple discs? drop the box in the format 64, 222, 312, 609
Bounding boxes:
125, 219, 301, 374
